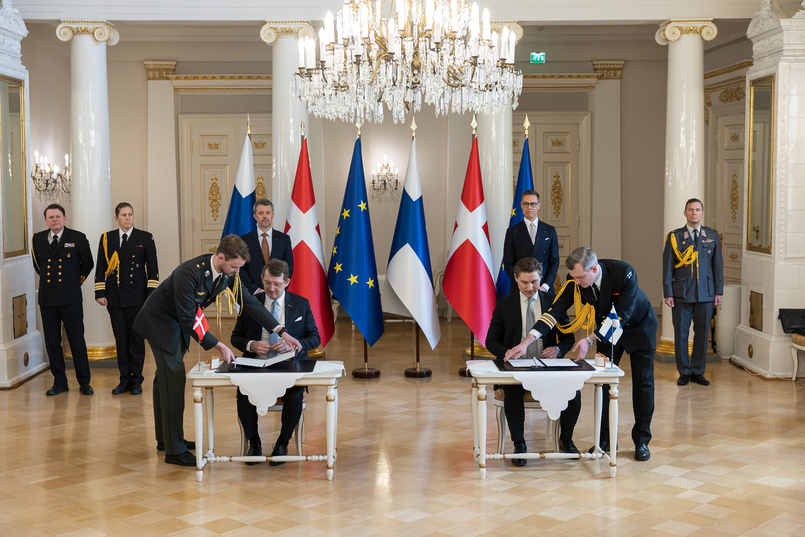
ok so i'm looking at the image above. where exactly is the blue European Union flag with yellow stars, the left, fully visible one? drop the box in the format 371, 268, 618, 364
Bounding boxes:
327, 138, 384, 346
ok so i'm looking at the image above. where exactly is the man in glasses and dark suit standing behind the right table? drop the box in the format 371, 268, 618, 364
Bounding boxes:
503, 190, 559, 293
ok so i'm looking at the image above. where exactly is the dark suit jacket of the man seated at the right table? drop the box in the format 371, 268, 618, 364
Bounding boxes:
486, 290, 576, 358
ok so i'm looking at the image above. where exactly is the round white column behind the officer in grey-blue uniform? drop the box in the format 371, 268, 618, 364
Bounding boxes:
654, 20, 718, 354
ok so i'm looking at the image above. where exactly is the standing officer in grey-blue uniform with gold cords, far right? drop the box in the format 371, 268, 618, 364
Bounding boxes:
662, 198, 724, 386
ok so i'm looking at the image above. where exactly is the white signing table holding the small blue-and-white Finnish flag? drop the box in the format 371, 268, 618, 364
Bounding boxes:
467, 360, 624, 479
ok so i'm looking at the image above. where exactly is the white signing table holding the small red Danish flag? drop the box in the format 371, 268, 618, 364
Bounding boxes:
187, 361, 344, 481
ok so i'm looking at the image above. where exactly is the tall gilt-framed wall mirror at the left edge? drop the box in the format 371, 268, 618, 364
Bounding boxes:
0, 76, 28, 258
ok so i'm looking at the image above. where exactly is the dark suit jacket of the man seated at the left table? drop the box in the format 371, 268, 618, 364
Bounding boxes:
231, 291, 321, 360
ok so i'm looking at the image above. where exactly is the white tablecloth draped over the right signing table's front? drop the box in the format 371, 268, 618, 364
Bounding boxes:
467, 360, 593, 420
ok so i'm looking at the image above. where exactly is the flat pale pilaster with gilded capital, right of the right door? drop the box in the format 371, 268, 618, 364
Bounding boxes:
590, 60, 626, 259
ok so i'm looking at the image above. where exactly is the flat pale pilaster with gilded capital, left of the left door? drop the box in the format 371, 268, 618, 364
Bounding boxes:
145, 60, 181, 279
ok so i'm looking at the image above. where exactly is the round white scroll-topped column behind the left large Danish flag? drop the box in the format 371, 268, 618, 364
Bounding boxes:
260, 21, 315, 230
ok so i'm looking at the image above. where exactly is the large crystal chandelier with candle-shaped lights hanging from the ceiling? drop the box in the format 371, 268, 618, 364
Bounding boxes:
292, 0, 523, 123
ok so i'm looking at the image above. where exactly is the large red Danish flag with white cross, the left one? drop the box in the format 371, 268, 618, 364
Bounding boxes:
285, 139, 335, 347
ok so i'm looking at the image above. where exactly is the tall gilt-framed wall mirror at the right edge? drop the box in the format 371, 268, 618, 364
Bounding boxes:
746, 75, 774, 254
